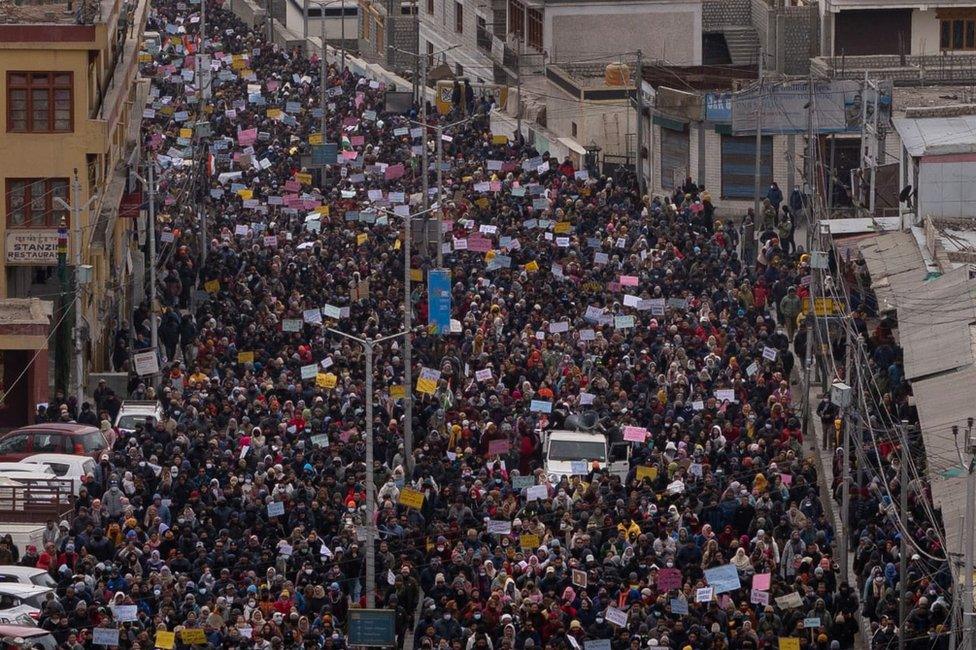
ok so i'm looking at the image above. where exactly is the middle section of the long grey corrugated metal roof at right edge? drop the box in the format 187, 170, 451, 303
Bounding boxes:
893, 267, 976, 380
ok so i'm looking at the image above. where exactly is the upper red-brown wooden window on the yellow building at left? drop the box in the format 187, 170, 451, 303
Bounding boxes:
7, 72, 74, 133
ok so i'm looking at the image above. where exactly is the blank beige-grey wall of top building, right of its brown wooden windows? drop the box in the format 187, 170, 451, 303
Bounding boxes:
542, 2, 702, 65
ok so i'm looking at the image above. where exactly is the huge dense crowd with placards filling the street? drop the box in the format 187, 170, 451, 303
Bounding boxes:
0, 0, 948, 650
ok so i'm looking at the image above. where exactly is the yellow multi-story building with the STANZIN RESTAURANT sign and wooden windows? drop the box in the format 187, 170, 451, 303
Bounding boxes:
0, 0, 149, 404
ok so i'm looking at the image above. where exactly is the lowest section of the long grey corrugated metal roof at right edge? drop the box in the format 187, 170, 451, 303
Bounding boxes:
912, 366, 976, 553
